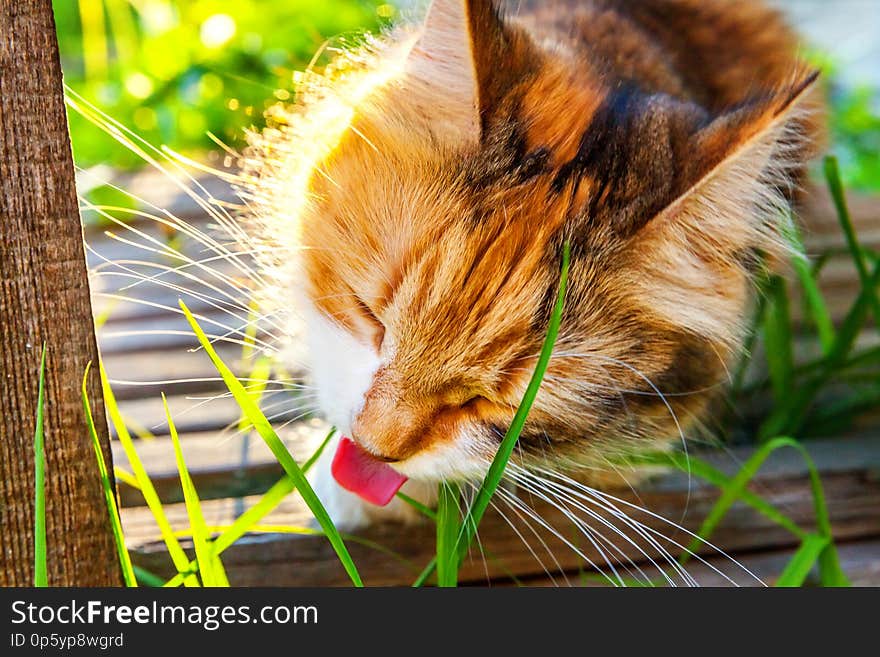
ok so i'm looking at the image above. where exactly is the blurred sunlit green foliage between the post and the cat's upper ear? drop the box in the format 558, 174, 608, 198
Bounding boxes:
53, 0, 395, 168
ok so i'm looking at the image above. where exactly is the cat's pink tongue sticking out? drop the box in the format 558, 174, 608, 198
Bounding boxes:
330, 436, 406, 506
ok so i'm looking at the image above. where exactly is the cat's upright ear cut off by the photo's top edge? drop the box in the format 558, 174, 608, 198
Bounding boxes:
405, 0, 528, 143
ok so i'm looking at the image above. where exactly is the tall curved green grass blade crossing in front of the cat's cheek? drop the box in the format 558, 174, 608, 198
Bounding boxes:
458, 242, 570, 563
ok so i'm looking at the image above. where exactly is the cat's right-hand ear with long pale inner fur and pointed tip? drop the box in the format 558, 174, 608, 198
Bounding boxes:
632, 74, 819, 341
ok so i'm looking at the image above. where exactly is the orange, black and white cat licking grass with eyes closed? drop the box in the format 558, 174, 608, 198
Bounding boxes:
242, 0, 821, 528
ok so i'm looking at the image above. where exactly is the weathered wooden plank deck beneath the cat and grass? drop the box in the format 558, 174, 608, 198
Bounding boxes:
87, 168, 880, 585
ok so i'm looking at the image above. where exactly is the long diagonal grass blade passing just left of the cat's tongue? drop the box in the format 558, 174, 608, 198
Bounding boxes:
180, 301, 363, 586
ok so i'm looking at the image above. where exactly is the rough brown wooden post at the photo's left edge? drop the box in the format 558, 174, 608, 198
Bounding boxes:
0, 0, 122, 586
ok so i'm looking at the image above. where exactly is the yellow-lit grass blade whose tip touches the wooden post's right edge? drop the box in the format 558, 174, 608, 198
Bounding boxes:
100, 364, 199, 586
